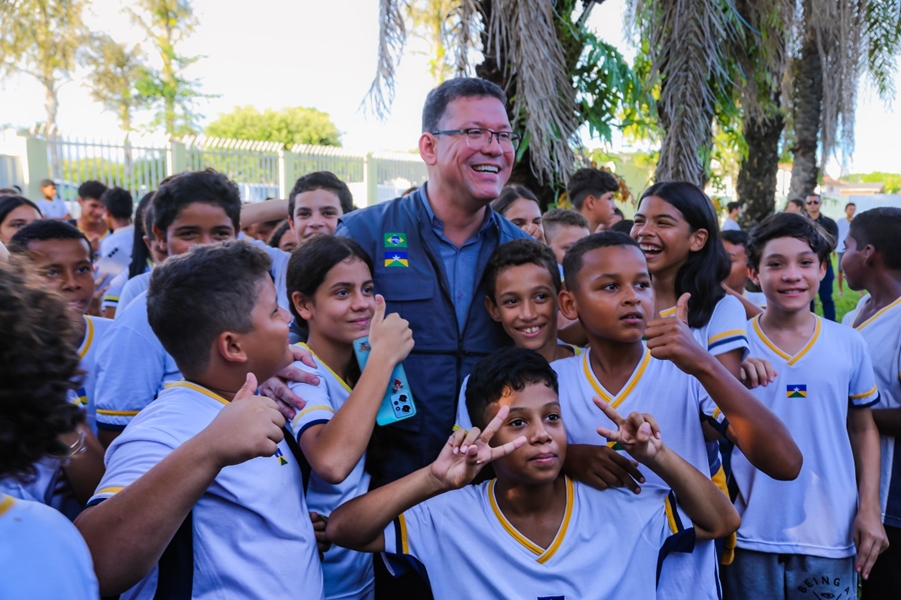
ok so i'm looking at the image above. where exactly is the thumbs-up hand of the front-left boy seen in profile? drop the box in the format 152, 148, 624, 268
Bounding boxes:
199, 373, 285, 467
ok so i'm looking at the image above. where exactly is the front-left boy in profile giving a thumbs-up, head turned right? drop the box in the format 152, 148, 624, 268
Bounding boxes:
76, 241, 322, 599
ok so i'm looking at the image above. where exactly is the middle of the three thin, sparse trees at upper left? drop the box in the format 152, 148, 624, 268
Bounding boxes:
86, 35, 150, 133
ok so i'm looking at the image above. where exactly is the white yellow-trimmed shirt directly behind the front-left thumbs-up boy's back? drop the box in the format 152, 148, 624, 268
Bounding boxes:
95, 292, 181, 431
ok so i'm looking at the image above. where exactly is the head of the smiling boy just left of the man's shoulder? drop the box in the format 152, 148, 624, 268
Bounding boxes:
288, 171, 354, 244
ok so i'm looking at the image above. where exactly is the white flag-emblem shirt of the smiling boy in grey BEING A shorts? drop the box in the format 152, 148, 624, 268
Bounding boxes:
732, 317, 878, 558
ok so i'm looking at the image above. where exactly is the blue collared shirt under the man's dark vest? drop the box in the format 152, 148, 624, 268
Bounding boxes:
421, 192, 491, 333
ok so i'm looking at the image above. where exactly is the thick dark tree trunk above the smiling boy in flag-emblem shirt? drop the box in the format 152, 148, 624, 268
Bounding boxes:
736, 113, 785, 227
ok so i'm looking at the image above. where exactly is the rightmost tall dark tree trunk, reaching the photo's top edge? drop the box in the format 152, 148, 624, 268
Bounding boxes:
788, 0, 823, 199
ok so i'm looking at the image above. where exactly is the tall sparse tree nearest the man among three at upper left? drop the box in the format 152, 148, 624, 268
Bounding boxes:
125, 0, 207, 135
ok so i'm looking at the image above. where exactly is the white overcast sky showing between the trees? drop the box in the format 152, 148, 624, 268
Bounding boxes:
0, 0, 901, 175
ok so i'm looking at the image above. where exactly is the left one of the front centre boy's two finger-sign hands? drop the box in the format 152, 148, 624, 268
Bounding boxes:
430, 406, 526, 490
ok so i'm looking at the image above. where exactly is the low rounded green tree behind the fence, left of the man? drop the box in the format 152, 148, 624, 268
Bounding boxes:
204, 106, 341, 148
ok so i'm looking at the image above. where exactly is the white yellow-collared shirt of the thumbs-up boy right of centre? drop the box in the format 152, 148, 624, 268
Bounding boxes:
551, 347, 727, 599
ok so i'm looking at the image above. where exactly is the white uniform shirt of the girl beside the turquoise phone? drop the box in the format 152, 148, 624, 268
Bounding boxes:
289, 344, 375, 600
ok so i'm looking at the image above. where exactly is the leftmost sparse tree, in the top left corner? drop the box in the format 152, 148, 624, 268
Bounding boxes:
0, 0, 90, 134
